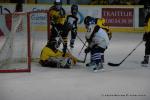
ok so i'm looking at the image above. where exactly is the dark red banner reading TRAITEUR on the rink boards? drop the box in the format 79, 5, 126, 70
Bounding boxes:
102, 8, 134, 27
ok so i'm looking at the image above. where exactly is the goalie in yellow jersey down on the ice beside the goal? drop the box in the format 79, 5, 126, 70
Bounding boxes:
39, 41, 78, 68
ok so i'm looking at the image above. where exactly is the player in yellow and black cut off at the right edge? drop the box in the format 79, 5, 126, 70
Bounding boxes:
141, 6, 150, 64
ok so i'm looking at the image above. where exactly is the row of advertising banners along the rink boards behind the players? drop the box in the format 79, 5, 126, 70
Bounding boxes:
0, 3, 144, 34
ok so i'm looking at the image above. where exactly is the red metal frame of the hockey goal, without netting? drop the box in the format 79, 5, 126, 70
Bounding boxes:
0, 10, 51, 73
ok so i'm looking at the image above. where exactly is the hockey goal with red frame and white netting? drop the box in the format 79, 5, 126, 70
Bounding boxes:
0, 11, 50, 72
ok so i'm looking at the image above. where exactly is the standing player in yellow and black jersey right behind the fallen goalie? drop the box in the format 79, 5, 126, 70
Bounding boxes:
48, 0, 74, 56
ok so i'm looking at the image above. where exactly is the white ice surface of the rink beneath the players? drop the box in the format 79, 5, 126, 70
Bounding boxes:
0, 33, 150, 100
